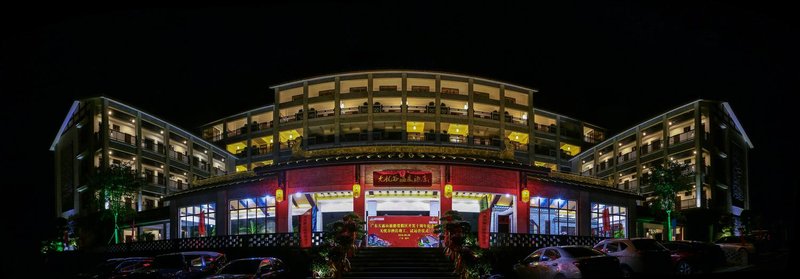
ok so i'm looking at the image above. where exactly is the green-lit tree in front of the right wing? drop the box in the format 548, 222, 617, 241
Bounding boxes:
647, 161, 693, 241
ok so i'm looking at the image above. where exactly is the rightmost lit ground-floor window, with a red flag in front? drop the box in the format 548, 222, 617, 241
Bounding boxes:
591, 203, 628, 238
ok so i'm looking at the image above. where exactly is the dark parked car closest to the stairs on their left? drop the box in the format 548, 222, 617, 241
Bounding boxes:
206, 257, 289, 279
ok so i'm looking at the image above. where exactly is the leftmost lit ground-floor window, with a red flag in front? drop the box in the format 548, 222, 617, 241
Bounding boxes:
178, 203, 217, 238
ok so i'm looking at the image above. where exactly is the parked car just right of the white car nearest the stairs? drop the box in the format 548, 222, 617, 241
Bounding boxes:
594, 238, 671, 277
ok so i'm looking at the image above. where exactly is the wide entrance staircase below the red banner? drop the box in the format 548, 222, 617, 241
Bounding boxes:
344, 248, 458, 279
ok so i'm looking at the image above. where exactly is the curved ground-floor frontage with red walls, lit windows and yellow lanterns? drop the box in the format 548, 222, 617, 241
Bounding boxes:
169, 163, 639, 246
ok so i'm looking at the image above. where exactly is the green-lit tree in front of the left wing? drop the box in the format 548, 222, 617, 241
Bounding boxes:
89, 164, 143, 244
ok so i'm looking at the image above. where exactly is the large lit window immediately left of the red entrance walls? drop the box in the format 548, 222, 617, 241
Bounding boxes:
228, 196, 275, 235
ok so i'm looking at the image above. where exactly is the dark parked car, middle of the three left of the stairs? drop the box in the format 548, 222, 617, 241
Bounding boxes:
131, 251, 226, 279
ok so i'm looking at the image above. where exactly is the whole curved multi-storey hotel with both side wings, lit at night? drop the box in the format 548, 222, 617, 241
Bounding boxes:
51, 71, 751, 246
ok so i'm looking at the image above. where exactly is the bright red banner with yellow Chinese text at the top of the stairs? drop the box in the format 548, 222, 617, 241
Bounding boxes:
367, 216, 439, 248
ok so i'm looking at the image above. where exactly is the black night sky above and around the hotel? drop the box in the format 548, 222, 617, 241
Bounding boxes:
0, 1, 798, 272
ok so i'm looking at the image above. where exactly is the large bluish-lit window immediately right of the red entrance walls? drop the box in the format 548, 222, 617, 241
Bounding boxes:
529, 197, 578, 235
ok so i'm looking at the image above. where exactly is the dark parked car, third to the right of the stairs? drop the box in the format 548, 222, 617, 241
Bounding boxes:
661, 241, 725, 275
